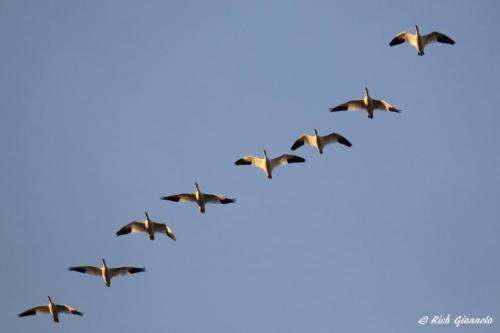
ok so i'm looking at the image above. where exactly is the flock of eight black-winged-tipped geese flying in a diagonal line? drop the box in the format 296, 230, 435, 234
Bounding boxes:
19, 26, 455, 323
